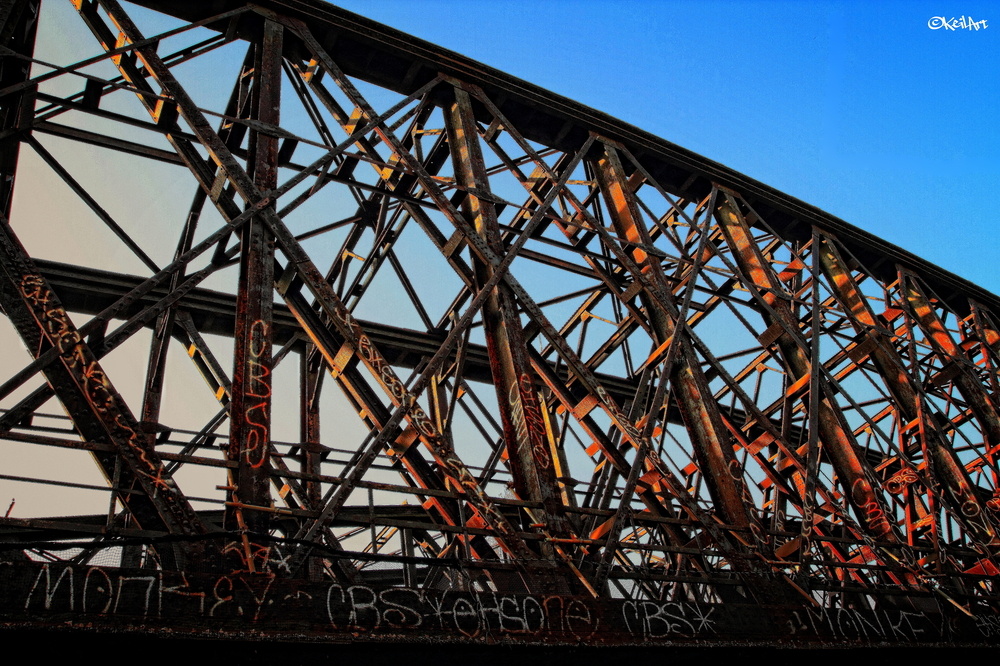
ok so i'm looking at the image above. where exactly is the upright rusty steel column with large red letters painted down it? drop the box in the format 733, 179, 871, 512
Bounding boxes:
225, 20, 283, 544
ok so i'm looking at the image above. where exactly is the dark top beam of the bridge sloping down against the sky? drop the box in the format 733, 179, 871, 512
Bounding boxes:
105, 0, 1000, 322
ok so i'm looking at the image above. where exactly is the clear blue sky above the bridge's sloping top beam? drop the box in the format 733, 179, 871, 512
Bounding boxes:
335, 0, 1000, 293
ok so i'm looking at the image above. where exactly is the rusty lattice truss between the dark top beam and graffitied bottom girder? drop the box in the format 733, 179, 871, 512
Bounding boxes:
0, 0, 1000, 609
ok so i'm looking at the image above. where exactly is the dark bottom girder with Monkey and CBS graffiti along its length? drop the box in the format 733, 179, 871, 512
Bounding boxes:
0, 563, 988, 644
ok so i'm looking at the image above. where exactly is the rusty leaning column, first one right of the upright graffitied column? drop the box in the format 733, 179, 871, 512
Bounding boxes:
445, 87, 569, 535
